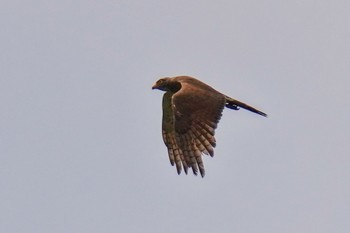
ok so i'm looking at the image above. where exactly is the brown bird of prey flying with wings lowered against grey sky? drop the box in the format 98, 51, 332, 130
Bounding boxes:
152, 76, 267, 177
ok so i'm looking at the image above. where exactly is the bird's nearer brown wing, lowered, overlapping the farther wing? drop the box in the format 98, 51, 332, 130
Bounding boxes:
171, 82, 225, 176
